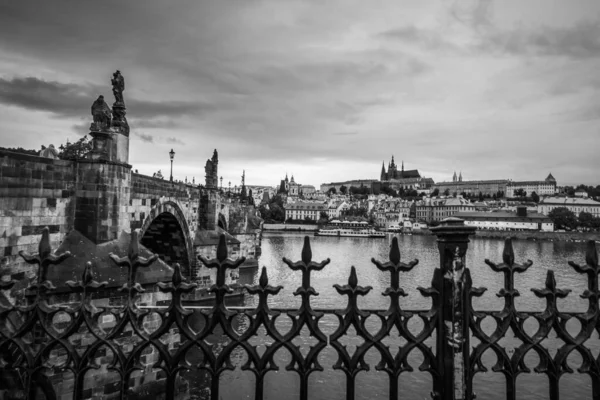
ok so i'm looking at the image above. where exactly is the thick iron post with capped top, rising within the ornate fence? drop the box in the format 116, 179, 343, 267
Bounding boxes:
431, 217, 475, 400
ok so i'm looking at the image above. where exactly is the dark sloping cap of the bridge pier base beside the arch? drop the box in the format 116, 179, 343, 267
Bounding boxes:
48, 230, 173, 292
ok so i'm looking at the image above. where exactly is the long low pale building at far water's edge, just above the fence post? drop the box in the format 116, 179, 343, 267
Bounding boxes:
454, 207, 554, 232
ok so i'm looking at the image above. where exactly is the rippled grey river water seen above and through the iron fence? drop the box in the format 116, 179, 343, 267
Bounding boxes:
188, 233, 600, 399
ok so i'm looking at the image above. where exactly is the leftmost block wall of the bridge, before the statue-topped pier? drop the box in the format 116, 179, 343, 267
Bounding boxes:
0, 150, 76, 289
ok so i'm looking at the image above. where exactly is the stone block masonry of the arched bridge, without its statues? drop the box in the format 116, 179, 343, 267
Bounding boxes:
0, 151, 260, 300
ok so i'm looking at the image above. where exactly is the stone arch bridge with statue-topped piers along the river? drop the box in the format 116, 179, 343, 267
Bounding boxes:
0, 74, 262, 305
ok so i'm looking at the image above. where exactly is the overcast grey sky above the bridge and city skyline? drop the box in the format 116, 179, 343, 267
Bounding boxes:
0, 0, 600, 186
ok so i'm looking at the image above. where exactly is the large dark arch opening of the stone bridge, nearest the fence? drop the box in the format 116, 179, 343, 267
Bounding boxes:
140, 200, 196, 276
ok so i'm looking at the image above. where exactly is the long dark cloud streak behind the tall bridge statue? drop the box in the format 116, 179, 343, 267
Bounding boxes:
0, 77, 205, 119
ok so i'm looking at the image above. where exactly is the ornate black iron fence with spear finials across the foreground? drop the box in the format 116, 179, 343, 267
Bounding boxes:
0, 218, 600, 400
